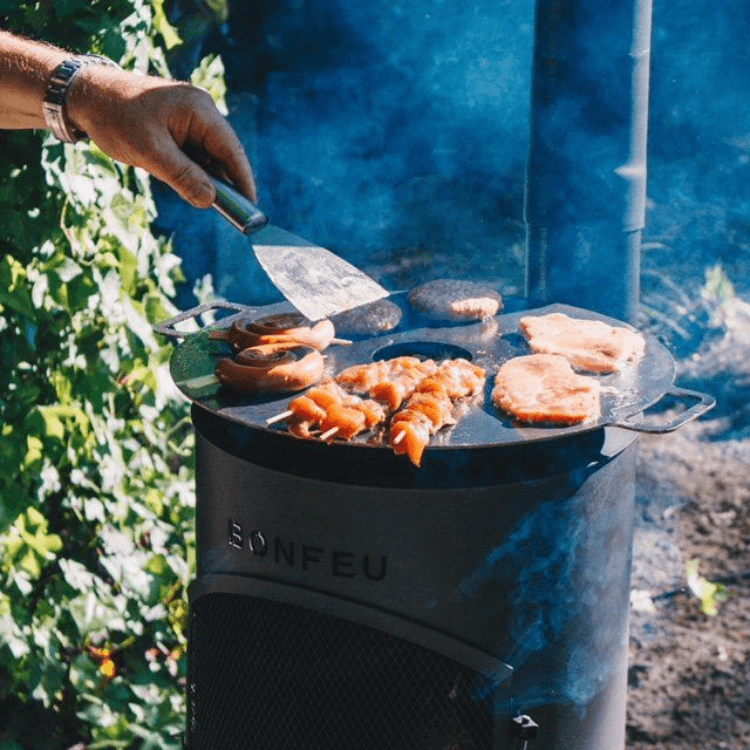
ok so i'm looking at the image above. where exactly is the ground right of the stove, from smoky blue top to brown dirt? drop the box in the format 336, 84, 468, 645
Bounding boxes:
627, 182, 750, 750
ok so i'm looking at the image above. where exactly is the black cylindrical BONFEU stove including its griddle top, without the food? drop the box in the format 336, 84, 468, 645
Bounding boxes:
160, 295, 711, 750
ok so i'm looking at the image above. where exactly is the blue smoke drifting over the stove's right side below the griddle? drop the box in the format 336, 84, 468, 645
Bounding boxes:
460, 490, 630, 714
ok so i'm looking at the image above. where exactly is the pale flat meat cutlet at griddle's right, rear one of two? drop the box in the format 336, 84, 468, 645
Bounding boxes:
519, 313, 646, 373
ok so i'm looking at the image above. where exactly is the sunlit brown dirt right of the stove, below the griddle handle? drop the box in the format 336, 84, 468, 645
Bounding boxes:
627, 421, 750, 750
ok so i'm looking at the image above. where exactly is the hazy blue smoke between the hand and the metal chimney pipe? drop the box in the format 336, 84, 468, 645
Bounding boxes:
236, 0, 533, 264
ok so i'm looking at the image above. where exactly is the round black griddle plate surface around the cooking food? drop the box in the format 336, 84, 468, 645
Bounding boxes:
171, 293, 710, 450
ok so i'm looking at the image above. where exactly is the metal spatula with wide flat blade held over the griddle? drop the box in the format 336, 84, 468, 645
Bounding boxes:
211, 176, 390, 320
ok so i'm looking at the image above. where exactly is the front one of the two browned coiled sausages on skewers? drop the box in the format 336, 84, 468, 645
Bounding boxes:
216, 344, 325, 394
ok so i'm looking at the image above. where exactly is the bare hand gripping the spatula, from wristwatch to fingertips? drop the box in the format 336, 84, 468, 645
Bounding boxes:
67, 65, 258, 208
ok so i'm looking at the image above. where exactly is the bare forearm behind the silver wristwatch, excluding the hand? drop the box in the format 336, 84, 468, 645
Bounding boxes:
0, 31, 70, 129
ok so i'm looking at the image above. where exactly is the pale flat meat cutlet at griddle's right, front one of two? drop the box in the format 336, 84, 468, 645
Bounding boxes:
492, 354, 601, 425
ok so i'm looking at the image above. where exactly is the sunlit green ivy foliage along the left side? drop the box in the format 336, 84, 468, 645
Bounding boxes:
0, 0, 228, 750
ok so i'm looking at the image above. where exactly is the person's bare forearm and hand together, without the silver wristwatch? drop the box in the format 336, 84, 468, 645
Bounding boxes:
0, 31, 257, 208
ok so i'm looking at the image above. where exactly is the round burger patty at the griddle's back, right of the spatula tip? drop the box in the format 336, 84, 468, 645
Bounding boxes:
409, 279, 503, 323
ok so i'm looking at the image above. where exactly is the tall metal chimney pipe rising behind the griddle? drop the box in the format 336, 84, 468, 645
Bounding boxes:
525, 0, 652, 323
